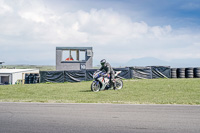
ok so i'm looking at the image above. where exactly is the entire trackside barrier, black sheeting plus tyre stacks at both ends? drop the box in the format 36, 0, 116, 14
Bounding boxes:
25, 66, 200, 84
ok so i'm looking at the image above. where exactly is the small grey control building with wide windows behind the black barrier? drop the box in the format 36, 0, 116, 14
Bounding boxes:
56, 47, 93, 71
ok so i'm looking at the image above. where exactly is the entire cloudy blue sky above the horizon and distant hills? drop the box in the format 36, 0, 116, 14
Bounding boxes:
0, 0, 200, 65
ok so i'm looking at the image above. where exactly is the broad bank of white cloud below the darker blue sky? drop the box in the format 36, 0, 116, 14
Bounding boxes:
0, 0, 200, 64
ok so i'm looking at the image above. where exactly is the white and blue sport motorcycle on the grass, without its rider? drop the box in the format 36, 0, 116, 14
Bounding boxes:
91, 70, 123, 92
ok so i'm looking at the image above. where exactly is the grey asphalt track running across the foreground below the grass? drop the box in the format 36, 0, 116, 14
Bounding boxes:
0, 103, 200, 133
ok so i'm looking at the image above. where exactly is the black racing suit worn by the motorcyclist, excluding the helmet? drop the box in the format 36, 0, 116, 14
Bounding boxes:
100, 63, 116, 88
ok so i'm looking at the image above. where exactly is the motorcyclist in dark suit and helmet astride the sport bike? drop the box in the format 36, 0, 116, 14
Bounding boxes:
100, 59, 116, 90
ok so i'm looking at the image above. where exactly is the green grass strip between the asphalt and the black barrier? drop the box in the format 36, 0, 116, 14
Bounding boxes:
0, 79, 200, 105
